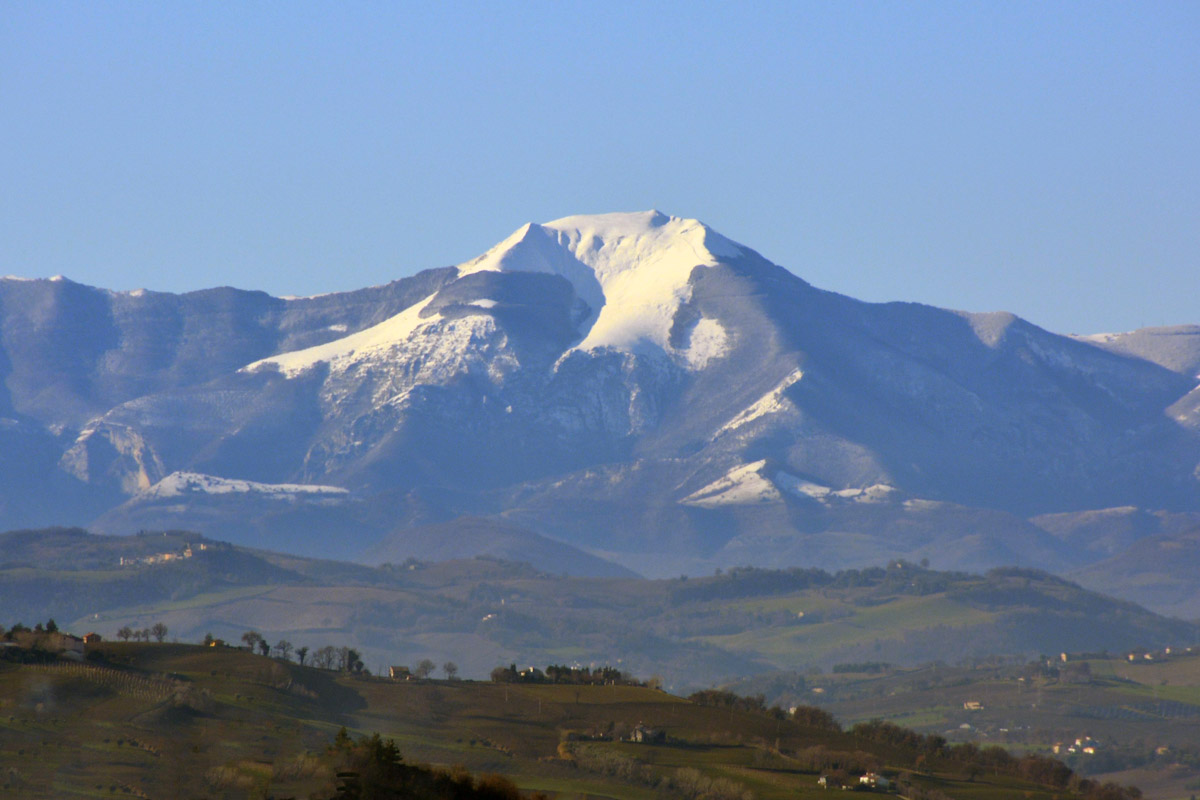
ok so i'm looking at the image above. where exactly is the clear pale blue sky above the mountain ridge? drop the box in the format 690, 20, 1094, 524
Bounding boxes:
0, 0, 1200, 332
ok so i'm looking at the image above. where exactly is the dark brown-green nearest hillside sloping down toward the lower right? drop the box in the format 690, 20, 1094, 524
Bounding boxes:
0, 644, 1130, 800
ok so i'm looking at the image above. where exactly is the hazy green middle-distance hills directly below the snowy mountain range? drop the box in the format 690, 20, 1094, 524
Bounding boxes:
0, 529, 1198, 690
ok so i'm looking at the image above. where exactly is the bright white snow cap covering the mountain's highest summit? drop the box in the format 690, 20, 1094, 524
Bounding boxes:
460, 211, 743, 357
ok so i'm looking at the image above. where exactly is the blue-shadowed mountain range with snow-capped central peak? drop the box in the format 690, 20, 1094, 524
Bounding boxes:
0, 211, 1200, 587
